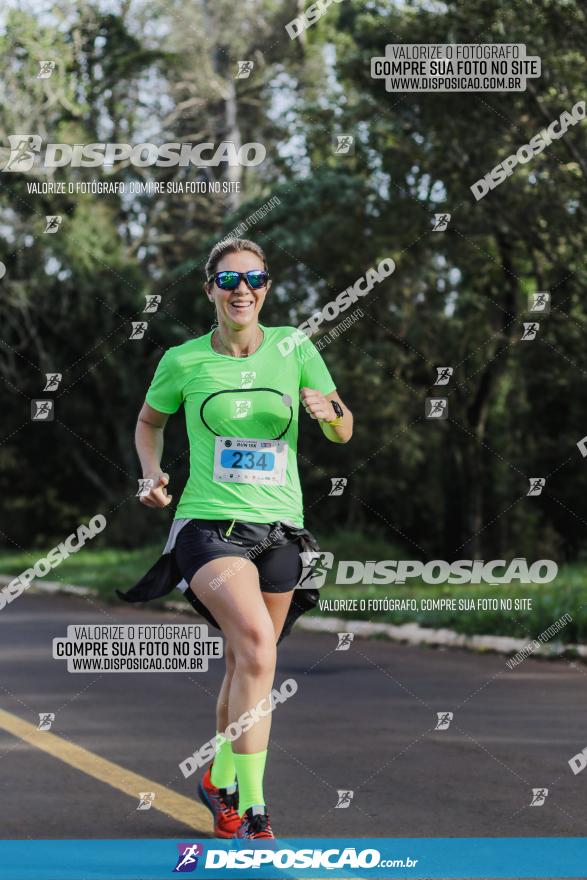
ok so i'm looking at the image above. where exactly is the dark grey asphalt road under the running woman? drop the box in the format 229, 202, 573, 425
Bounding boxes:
0, 595, 587, 839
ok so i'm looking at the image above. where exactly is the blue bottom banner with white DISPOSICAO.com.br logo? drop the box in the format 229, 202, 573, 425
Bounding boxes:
0, 837, 587, 880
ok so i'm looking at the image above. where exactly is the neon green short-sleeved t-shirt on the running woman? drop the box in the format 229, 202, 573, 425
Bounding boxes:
146, 324, 336, 527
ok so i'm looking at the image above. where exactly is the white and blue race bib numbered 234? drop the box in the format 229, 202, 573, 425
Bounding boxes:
214, 437, 287, 486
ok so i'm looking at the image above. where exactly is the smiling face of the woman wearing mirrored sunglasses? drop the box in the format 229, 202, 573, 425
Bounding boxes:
208, 251, 271, 330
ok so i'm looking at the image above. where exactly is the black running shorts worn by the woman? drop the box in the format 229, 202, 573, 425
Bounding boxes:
175, 519, 302, 593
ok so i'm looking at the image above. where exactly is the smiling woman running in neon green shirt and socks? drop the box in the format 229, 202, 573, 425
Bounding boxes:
134, 239, 353, 838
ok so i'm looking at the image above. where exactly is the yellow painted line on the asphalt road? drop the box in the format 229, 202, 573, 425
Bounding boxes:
0, 709, 212, 834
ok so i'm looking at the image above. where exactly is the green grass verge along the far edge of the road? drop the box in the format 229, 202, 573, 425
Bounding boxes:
0, 532, 587, 644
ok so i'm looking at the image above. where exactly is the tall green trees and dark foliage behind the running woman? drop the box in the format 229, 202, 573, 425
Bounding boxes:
0, 0, 587, 568
